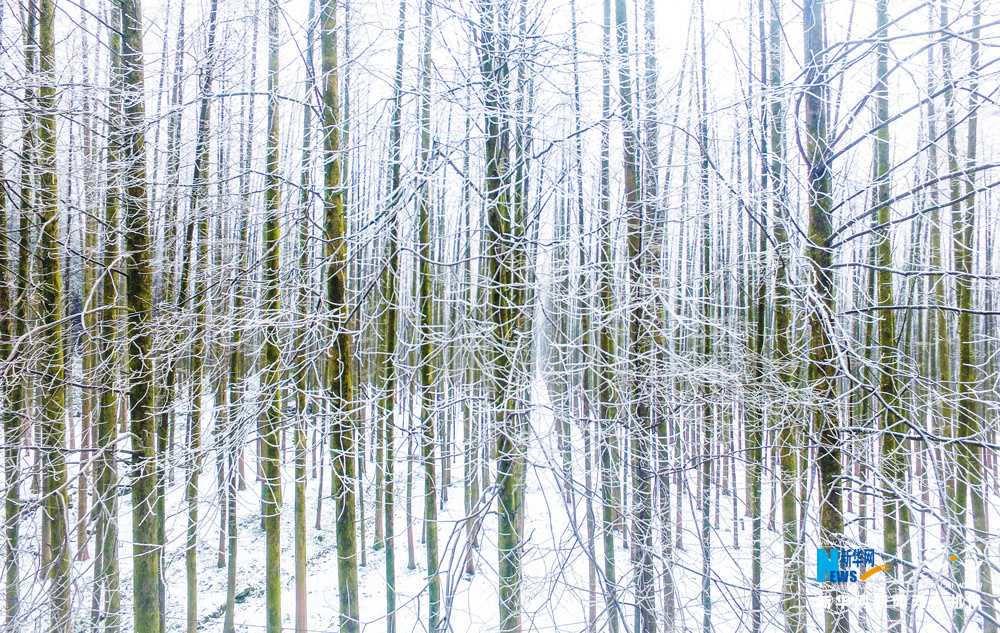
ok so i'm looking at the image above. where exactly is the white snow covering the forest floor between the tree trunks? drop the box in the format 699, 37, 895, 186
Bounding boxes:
11, 382, 997, 633
